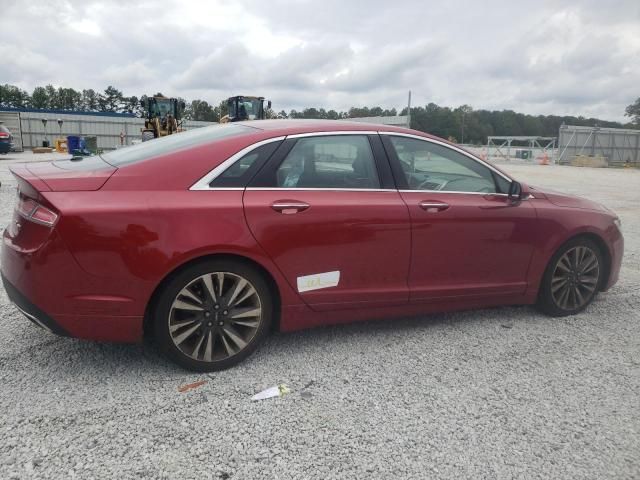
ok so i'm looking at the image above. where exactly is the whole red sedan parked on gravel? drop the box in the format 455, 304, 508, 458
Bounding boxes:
2, 120, 623, 371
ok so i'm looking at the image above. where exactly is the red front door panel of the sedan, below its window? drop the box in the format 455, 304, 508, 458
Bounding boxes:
402, 192, 537, 301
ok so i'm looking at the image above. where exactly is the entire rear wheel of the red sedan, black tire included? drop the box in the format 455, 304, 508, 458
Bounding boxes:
153, 259, 273, 372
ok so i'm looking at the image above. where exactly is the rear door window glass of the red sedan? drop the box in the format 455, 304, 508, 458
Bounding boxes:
276, 135, 380, 189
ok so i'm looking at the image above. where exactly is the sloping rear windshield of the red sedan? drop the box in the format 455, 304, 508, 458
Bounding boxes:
102, 124, 252, 167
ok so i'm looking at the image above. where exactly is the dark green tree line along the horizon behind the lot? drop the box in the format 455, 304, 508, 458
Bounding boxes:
0, 84, 640, 144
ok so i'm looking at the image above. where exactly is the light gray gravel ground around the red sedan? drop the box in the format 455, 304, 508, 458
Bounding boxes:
0, 154, 640, 479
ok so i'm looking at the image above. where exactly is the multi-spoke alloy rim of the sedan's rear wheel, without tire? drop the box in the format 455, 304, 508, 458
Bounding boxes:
168, 272, 263, 362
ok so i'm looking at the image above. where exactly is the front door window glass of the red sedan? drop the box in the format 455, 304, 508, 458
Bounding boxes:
390, 136, 502, 193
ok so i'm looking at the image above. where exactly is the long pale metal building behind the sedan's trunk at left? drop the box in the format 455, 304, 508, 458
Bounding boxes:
0, 109, 211, 151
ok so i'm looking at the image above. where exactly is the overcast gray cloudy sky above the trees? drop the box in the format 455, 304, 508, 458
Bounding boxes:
0, 0, 640, 120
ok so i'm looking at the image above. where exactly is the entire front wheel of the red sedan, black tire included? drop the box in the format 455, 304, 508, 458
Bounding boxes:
537, 237, 605, 317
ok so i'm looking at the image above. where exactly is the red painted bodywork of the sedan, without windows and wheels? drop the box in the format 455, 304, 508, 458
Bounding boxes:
1, 121, 624, 342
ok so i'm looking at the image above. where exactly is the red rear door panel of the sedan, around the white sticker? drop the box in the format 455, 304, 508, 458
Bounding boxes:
244, 190, 411, 310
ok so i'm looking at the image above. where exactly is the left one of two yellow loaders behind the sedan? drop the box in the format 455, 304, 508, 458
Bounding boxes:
140, 95, 186, 142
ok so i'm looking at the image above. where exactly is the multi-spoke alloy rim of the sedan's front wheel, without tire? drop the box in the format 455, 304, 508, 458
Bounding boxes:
551, 246, 600, 310
